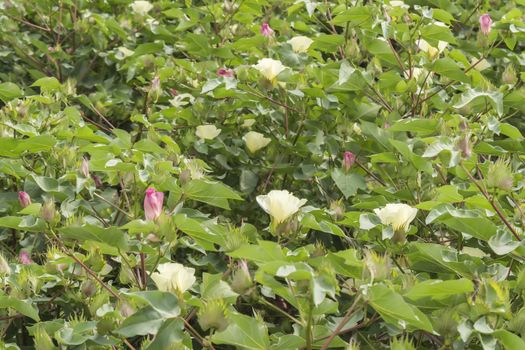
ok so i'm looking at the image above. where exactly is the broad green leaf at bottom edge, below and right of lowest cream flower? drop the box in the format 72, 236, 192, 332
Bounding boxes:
211, 313, 270, 350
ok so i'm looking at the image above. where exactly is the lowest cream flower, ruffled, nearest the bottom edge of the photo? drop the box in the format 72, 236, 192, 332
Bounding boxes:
151, 263, 196, 293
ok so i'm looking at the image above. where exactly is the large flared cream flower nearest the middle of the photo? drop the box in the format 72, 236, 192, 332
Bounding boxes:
257, 190, 306, 224
